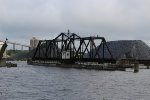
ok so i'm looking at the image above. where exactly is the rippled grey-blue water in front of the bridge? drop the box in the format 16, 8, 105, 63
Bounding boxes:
0, 62, 150, 100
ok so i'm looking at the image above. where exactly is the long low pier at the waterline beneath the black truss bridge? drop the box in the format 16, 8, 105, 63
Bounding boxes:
27, 60, 129, 71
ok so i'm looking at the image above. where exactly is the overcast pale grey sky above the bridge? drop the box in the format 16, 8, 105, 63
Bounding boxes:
0, 0, 150, 45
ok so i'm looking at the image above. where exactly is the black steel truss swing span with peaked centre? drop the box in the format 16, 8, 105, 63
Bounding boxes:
32, 32, 115, 63
